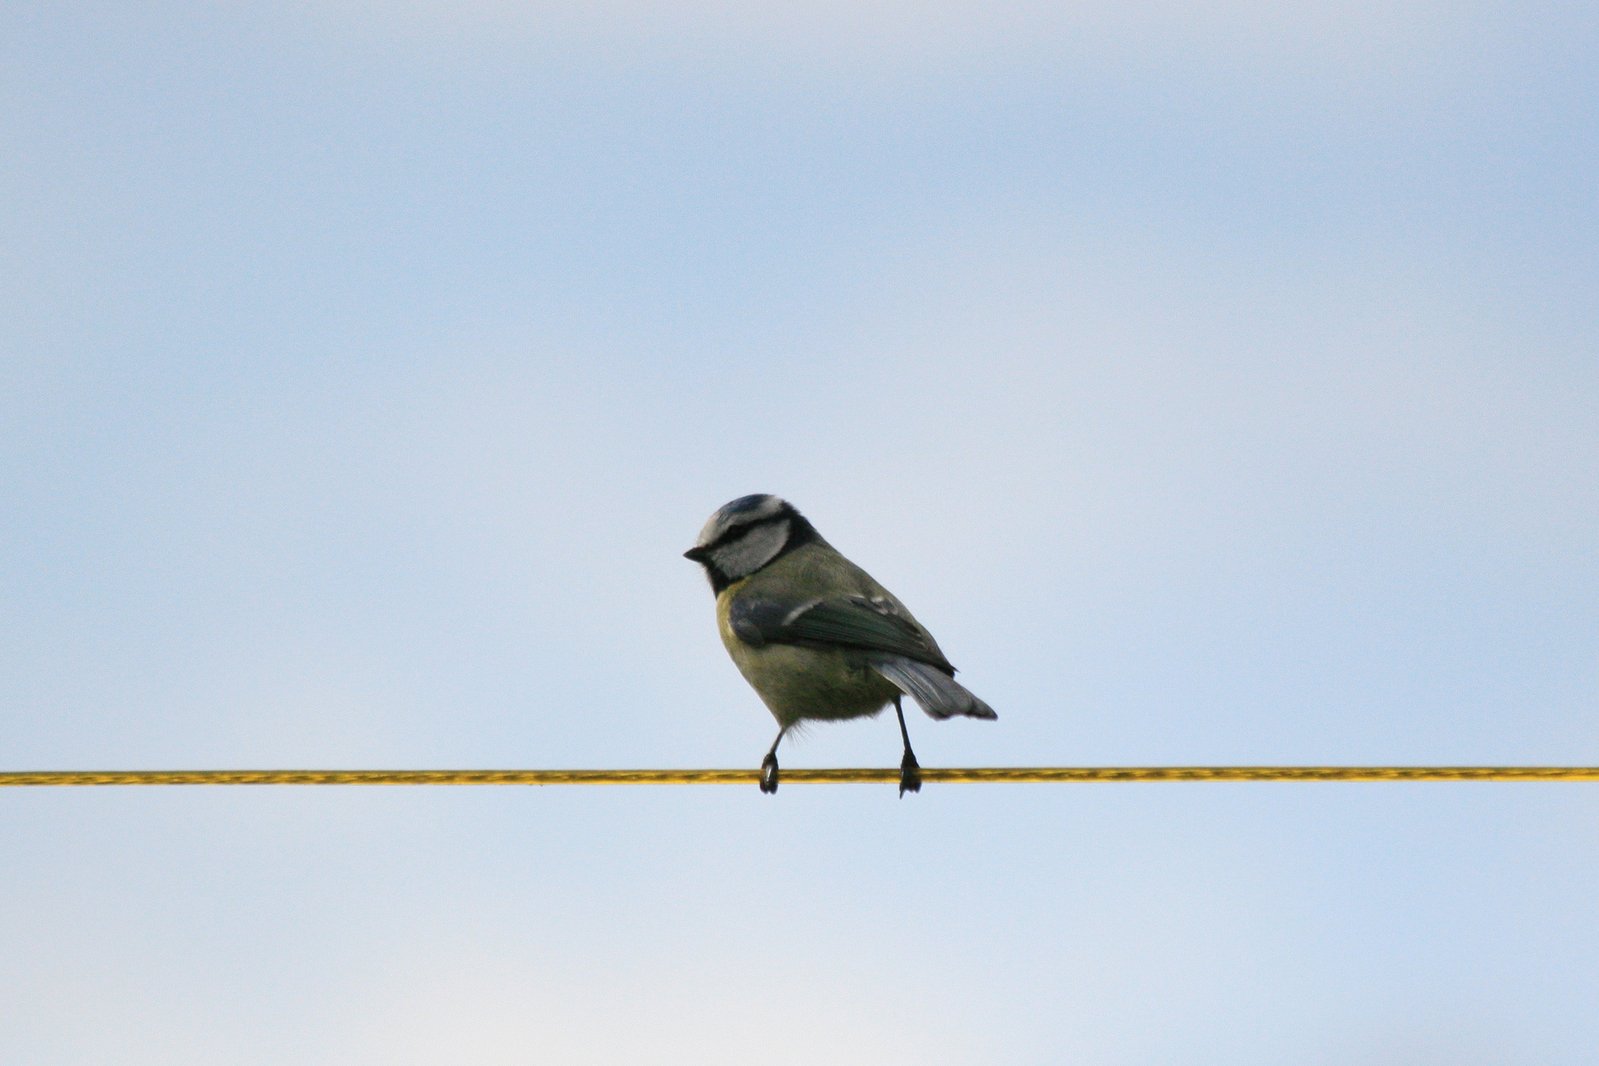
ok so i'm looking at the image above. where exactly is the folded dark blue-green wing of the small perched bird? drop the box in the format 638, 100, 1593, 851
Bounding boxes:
728, 596, 955, 673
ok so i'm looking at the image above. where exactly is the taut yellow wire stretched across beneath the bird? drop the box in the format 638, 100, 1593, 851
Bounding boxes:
0, 766, 1599, 788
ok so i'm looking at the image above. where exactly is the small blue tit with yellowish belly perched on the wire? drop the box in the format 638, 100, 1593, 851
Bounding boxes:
683, 495, 998, 796
